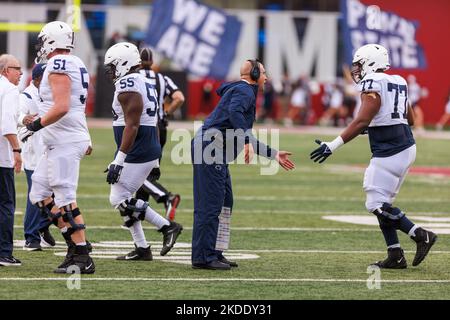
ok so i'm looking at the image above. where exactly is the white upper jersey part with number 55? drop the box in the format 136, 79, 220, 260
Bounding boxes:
112, 73, 158, 127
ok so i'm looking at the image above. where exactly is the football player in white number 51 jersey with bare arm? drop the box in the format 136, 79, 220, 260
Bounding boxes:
27, 21, 95, 274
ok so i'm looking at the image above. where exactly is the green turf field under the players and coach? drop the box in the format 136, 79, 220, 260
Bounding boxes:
0, 129, 450, 300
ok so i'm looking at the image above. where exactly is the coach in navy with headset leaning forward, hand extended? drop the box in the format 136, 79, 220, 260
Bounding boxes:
191, 60, 294, 270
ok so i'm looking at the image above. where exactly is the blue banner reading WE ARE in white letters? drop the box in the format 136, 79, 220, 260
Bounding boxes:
145, 0, 241, 79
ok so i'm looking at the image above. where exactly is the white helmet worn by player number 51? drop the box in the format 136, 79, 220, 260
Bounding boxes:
35, 21, 74, 63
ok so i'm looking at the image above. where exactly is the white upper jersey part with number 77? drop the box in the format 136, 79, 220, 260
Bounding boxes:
358, 73, 408, 127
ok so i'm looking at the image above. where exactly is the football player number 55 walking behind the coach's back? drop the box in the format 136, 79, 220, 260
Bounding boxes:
104, 42, 183, 261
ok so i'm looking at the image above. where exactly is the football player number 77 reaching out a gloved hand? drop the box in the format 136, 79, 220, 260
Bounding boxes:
311, 44, 437, 269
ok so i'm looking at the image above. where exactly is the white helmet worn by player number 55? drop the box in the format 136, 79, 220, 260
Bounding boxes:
104, 42, 141, 81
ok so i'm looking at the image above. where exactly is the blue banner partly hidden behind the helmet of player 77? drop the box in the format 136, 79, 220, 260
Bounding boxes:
341, 0, 427, 69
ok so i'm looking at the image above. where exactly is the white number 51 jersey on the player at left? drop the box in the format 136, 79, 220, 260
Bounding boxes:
39, 55, 90, 145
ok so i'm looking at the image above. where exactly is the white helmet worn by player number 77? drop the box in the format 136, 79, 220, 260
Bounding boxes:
351, 44, 391, 83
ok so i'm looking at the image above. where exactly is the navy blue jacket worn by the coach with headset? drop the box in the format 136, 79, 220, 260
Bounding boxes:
197, 80, 277, 161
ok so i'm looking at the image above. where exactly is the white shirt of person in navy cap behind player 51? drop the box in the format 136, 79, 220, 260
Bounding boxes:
18, 82, 45, 170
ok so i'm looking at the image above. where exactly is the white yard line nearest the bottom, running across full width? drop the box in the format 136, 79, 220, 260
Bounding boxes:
0, 276, 450, 283
